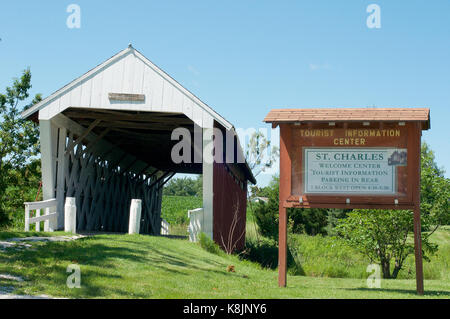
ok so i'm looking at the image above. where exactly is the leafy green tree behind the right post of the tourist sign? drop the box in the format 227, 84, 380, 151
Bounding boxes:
336, 143, 450, 278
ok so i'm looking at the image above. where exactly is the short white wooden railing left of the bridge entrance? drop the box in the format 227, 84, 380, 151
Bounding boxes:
24, 198, 57, 231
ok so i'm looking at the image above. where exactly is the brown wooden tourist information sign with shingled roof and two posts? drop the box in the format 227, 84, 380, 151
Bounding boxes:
264, 108, 430, 295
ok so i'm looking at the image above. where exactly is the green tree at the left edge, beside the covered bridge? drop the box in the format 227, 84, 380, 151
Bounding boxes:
0, 69, 41, 225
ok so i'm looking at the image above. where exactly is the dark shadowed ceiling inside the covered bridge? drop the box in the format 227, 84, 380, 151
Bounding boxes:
63, 108, 202, 174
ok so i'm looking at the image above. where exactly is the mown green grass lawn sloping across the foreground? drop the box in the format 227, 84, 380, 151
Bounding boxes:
0, 232, 450, 298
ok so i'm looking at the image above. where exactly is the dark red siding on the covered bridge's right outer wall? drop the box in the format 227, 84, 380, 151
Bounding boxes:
213, 163, 247, 254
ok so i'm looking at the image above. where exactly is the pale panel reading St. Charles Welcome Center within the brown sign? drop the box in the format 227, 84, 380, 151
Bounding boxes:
303, 148, 407, 195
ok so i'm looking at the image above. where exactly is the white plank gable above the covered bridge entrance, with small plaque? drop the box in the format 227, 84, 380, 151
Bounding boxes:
26, 47, 232, 129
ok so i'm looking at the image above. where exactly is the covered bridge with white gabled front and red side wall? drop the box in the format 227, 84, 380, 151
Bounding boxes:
22, 45, 255, 250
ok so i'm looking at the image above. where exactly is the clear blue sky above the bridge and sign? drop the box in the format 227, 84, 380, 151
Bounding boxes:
0, 0, 450, 184
